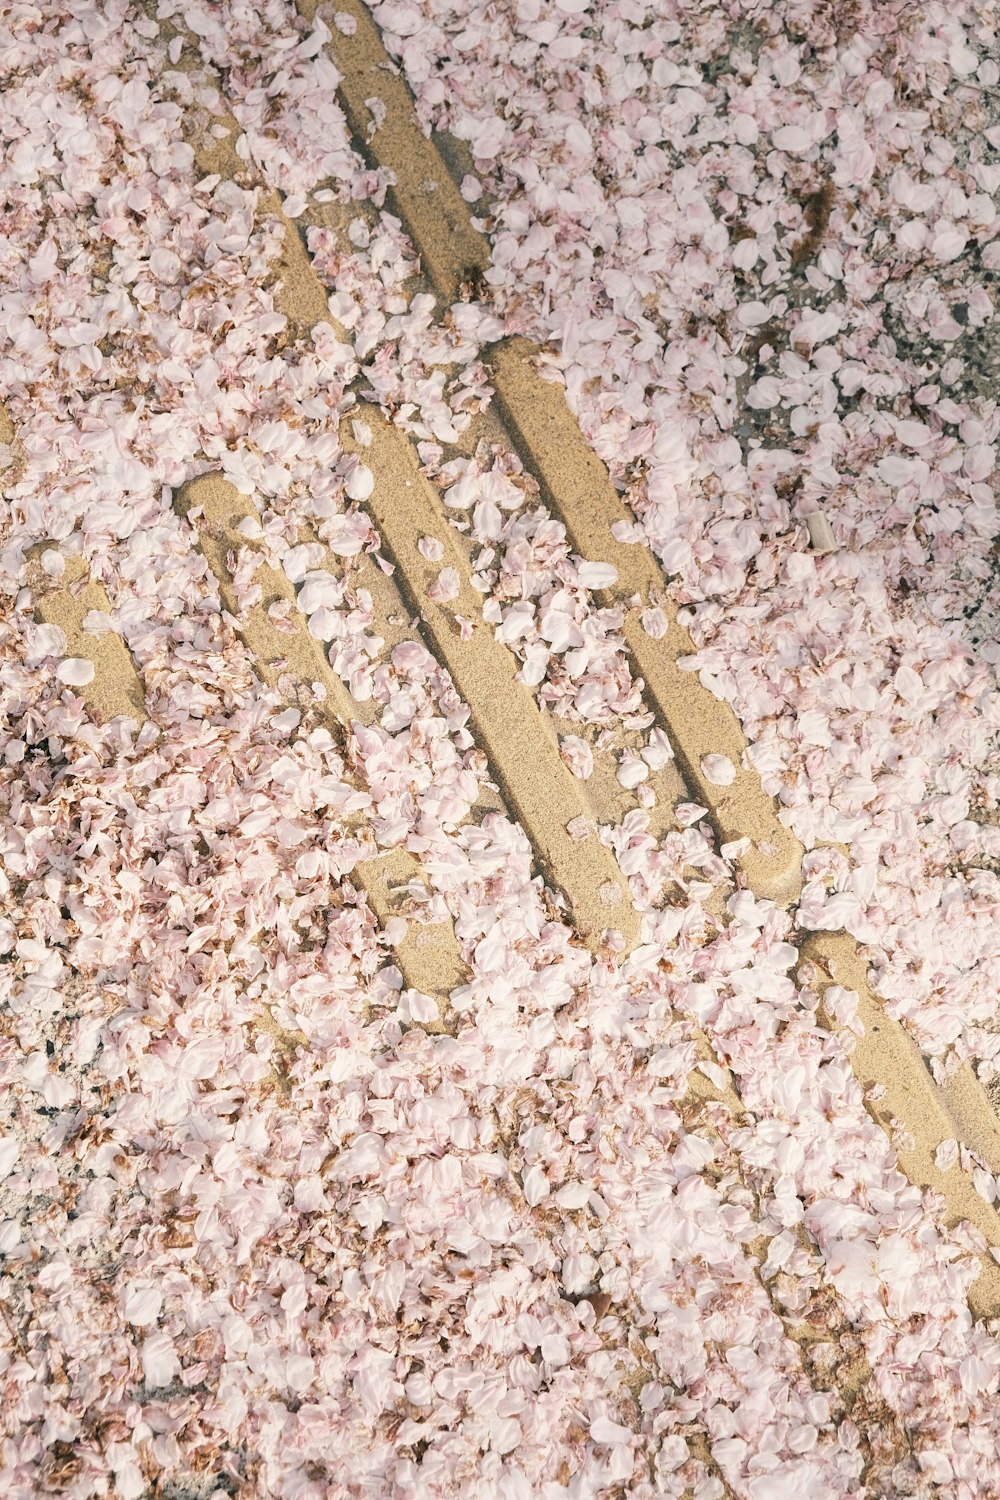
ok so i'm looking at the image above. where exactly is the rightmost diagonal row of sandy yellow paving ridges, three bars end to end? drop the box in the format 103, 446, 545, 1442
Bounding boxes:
287, 0, 1000, 1316
